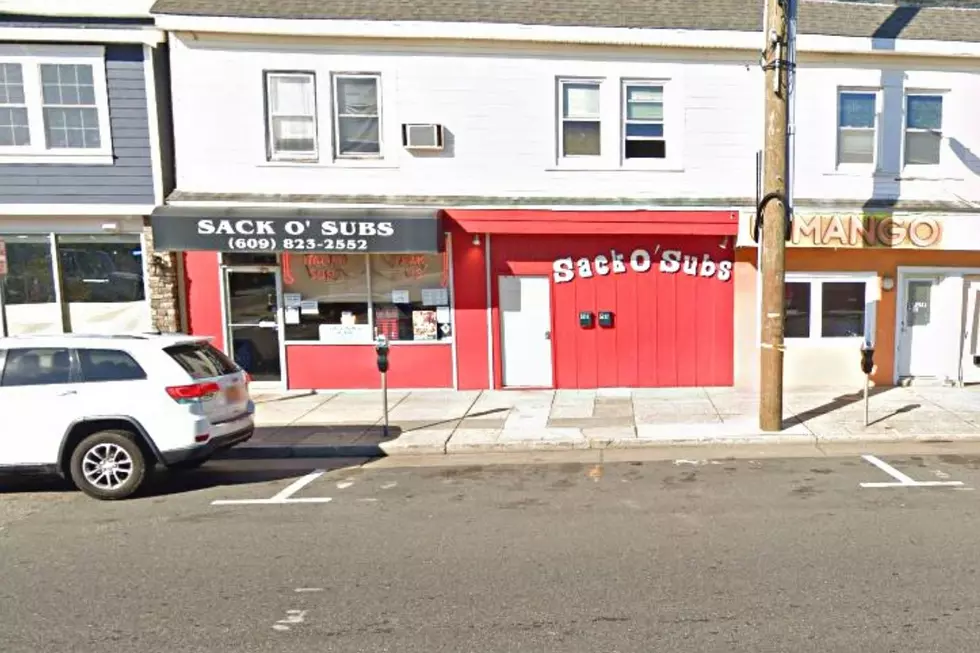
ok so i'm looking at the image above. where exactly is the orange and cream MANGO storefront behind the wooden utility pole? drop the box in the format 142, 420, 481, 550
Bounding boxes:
736, 211, 980, 391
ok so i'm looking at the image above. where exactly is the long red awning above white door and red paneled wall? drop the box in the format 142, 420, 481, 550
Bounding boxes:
443, 209, 738, 236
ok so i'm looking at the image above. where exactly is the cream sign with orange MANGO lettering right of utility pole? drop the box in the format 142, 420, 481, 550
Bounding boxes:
790, 215, 943, 249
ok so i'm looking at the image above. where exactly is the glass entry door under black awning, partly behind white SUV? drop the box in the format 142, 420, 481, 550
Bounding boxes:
225, 268, 282, 382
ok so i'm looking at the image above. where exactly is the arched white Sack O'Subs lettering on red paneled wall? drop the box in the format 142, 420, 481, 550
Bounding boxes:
552, 247, 732, 283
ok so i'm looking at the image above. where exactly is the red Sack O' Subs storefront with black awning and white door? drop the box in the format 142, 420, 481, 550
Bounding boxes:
153, 206, 738, 389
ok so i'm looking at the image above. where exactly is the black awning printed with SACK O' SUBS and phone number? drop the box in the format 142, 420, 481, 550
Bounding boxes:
150, 206, 444, 254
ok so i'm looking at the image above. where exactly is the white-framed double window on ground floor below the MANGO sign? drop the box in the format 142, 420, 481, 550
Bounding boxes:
784, 273, 877, 340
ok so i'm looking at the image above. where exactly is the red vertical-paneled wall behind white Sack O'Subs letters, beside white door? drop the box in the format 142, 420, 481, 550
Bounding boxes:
494, 236, 734, 389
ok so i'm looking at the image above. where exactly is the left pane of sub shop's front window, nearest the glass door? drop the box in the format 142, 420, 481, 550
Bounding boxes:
282, 254, 373, 343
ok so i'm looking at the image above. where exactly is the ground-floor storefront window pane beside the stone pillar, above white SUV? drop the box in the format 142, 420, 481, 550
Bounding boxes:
57, 235, 150, 333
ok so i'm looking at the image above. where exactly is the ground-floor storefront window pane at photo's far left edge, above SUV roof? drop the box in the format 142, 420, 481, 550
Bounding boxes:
2, 235, 62, 336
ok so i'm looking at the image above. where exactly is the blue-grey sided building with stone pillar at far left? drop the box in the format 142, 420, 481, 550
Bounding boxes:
0, 18, 174, 337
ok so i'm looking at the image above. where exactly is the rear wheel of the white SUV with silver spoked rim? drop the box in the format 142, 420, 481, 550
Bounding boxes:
71, 430, 147, 500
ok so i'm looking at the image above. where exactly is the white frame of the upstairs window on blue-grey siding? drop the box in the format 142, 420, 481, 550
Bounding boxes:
0, 43, 113, 165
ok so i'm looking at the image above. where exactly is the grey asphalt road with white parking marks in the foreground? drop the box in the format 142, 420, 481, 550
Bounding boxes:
0, 449, 980, 653
